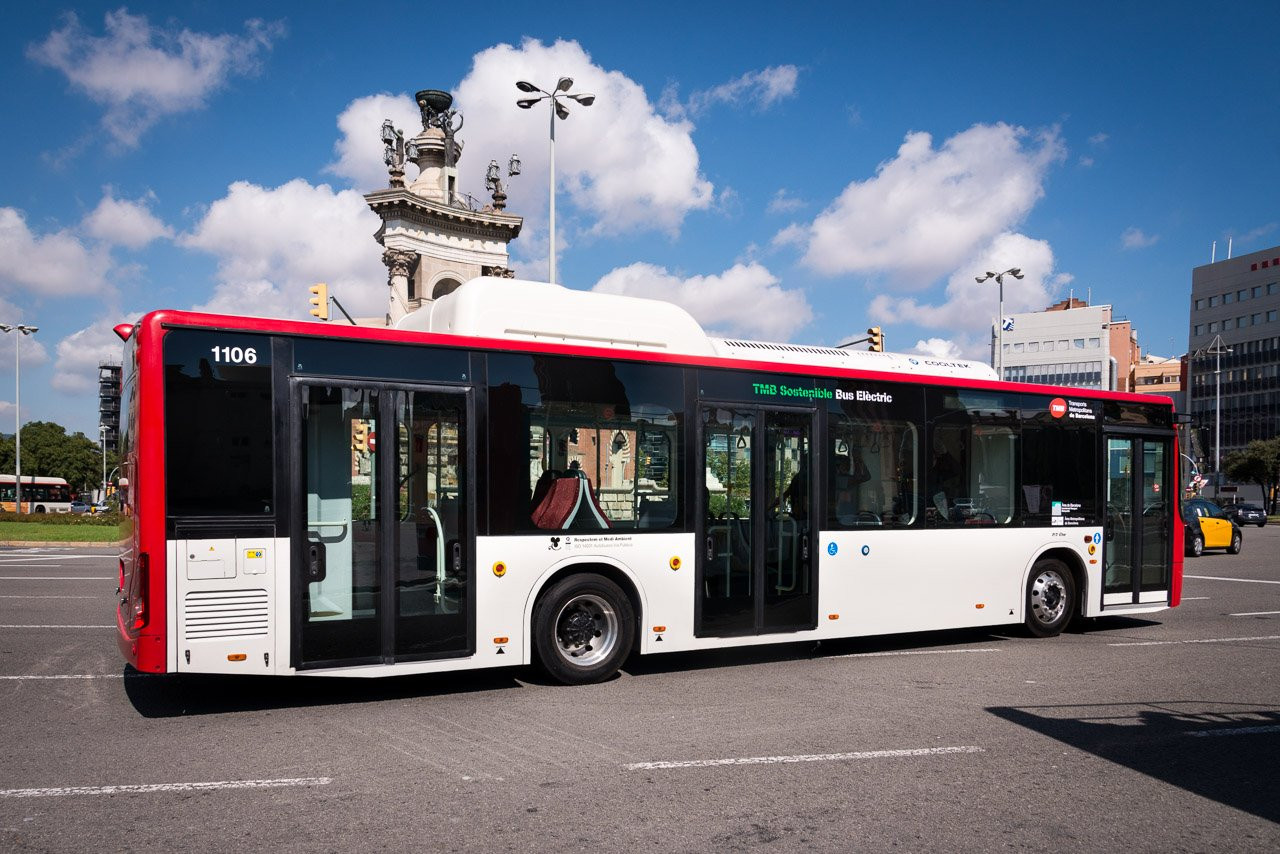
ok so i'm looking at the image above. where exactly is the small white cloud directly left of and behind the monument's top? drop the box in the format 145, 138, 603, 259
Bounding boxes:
326, 92, 419, 192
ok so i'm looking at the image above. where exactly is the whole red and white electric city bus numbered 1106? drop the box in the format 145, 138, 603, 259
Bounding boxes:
116, 279, 1181, 682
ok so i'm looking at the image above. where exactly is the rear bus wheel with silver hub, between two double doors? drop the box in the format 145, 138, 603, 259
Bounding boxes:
534, 572, 635, 685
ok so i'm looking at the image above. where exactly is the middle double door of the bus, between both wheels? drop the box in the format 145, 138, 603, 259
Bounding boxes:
696, 405, 817, 636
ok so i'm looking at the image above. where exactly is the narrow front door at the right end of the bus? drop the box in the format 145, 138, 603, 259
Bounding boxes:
1102, 434, 1178, 607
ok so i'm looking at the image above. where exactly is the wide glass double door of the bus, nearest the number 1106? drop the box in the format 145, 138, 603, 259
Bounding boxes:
293, 382, 475, 668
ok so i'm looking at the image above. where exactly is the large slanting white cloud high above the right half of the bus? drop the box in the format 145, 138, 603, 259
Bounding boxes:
774, 124, 1065, 289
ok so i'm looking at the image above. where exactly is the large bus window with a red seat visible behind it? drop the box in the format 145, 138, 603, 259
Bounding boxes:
489, 355, 682, 534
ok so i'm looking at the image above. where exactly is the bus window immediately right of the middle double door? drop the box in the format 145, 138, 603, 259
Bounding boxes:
827, 417, 919, 528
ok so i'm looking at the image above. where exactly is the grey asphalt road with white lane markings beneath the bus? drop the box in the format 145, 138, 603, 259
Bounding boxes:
0, 535, 1280, 854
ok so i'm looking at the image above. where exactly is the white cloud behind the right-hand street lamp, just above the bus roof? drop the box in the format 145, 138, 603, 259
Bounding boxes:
869, 233, 1070, 360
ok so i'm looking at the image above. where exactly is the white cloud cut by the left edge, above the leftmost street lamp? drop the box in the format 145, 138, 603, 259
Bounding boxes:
0, 207, 111, 297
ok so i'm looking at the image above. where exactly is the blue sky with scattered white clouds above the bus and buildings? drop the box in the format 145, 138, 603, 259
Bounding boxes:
0, 0, 1280, 435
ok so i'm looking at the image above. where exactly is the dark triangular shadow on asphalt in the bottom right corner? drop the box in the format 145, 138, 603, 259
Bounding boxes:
987, 700, 1280, 822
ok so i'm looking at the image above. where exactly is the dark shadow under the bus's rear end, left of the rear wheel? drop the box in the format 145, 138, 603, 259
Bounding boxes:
124, 667, 522, 718
